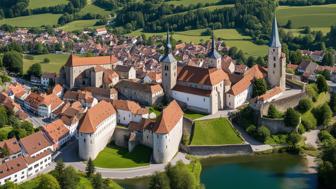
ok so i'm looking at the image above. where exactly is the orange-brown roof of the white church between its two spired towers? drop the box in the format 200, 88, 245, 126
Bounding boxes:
177, 66, 229, 86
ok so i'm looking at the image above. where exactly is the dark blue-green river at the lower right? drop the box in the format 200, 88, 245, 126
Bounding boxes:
118, 154, 317, 189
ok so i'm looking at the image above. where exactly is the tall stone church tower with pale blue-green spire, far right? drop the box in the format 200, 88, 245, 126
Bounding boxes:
267, 16, 286, 90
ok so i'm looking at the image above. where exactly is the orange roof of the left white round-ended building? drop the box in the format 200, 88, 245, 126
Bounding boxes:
79, 100, 116, 133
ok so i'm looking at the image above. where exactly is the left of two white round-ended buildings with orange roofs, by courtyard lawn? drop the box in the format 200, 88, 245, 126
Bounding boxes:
78, 101, 117, 160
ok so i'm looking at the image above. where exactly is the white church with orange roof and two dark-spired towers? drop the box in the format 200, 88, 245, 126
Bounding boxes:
161, 33, 231, 114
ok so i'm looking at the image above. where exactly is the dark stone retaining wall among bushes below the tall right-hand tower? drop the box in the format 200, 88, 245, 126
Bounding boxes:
260, 117, 294, 134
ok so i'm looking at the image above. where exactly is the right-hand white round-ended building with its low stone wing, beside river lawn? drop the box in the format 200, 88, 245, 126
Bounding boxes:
128, 100, 183, 163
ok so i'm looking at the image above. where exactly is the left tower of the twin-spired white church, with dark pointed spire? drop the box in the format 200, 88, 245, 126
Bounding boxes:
160, 30, 177, 99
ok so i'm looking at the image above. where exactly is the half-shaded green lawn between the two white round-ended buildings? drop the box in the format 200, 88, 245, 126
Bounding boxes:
94, 145, 152, 168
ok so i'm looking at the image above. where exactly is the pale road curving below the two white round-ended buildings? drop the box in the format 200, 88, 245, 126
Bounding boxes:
56, 140, 190, 179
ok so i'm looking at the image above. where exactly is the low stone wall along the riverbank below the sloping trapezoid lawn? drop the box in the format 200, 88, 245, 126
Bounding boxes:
181, 144, 253, 156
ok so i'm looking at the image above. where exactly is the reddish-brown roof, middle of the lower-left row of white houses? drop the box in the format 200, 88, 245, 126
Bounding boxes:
20, 131, 51, 155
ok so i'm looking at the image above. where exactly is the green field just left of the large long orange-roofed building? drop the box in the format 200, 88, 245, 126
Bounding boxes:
23, 54, 69, 73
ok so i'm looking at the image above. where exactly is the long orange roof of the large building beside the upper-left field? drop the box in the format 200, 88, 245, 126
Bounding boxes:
65, 55, 119, 67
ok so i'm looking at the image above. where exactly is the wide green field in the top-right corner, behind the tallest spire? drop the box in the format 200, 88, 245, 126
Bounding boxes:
277, 4, 336, 28
